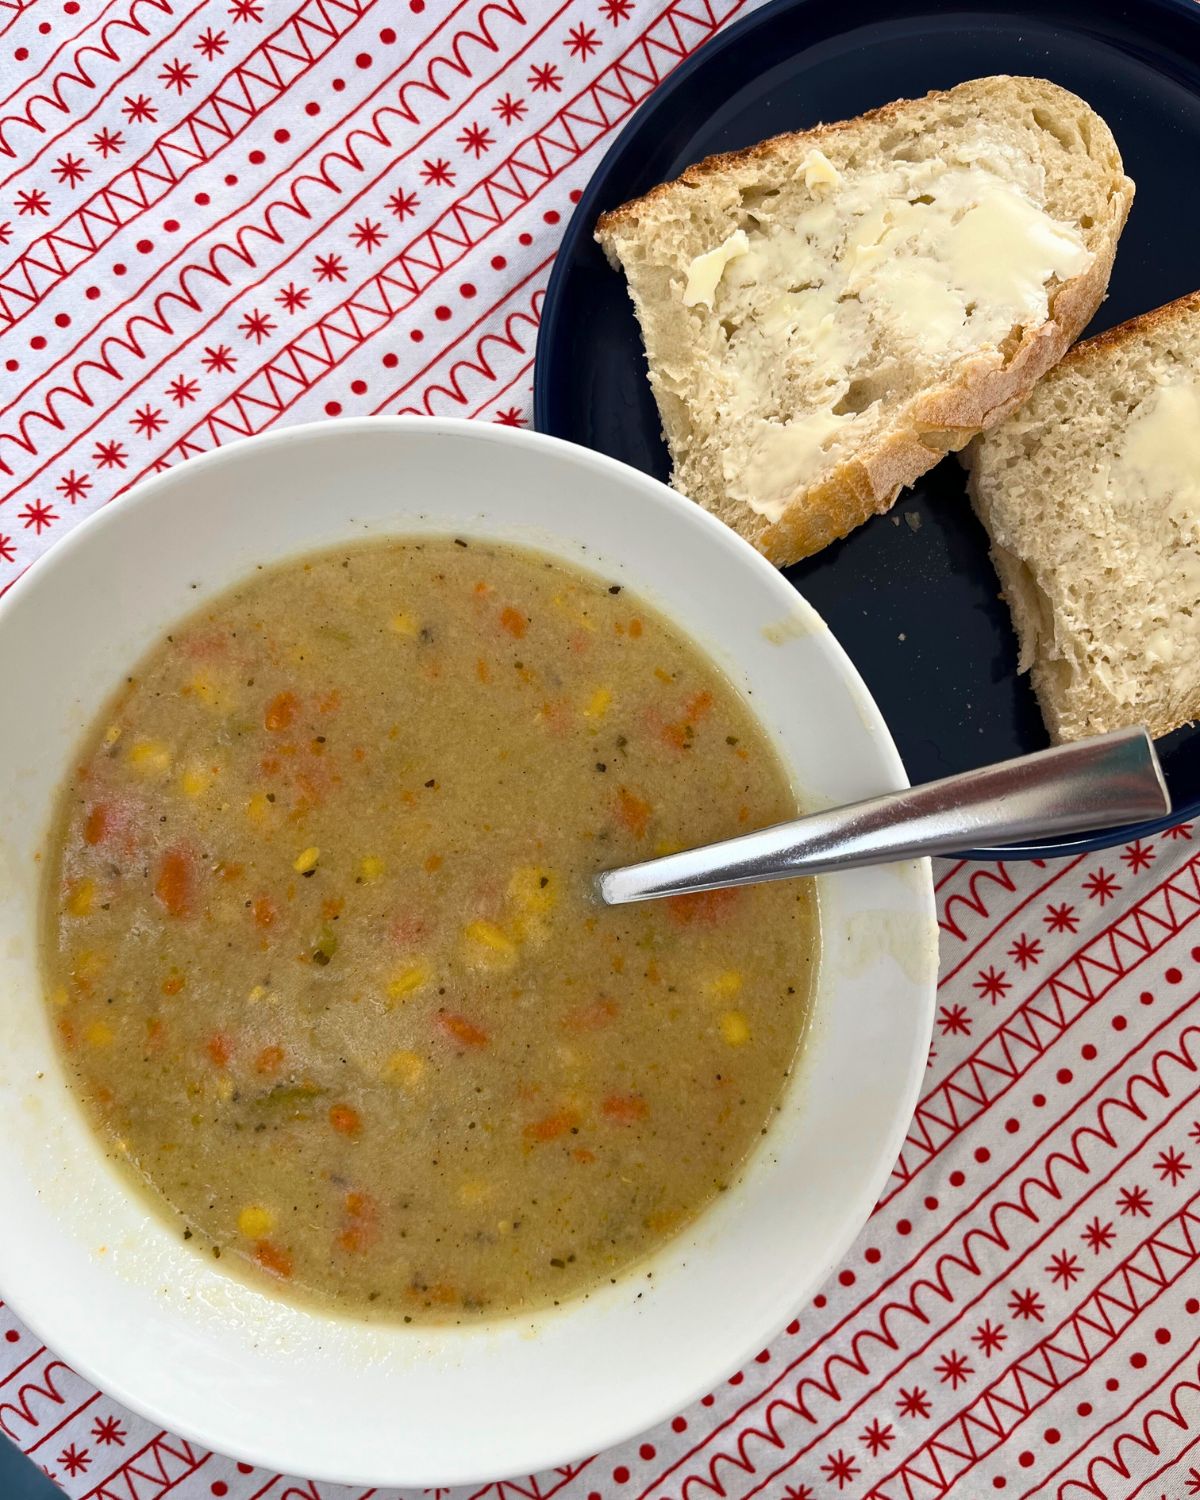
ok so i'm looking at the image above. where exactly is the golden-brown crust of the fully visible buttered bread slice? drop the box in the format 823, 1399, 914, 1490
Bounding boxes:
596, 75, 1134, 567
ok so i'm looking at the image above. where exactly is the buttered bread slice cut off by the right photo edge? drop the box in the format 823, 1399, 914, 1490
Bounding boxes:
965, 293, 1200, 741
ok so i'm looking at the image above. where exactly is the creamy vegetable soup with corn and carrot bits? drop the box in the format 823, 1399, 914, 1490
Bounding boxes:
45, 539, 818, 1323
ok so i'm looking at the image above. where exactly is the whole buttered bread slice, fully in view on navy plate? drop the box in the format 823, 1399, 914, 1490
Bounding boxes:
596, 78, 1133, 564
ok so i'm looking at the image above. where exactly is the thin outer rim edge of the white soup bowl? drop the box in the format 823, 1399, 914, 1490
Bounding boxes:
0, 416, 938, 1488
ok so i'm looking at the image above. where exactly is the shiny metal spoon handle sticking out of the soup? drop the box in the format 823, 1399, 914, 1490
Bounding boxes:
596, 726, 1172, 906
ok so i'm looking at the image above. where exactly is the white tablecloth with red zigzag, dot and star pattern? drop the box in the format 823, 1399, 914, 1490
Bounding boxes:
0, 0, 1200, 1500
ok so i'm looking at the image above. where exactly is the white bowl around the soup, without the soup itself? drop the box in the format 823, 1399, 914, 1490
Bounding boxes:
0, 417, 936, 1485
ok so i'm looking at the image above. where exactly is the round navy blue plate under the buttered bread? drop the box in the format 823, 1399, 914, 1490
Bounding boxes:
534, 0, 1200, 860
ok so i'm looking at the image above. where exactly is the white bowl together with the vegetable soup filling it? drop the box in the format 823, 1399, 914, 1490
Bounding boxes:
0, 419, 936, 1485
